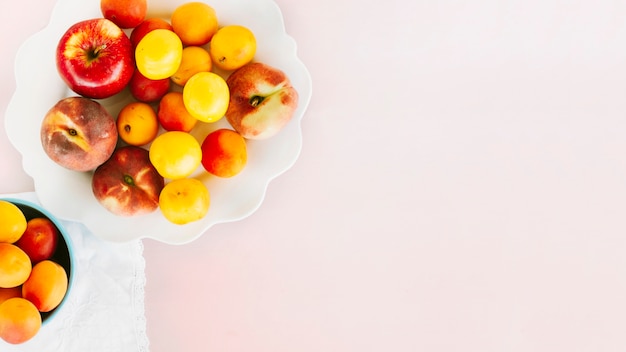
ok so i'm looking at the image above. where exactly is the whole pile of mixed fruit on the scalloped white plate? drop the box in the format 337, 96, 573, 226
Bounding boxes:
40, 0, 298, 225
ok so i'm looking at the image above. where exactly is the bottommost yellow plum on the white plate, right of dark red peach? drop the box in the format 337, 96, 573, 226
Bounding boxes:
159, 178, 211, 225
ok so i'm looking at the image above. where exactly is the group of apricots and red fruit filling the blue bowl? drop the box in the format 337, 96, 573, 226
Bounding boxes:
0, 200, 68, 344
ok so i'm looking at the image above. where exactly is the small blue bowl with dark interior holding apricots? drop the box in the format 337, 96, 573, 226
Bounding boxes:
0, 198, 74, 324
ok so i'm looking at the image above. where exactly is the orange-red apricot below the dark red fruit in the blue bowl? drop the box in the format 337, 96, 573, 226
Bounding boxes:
22, 260, 68, 312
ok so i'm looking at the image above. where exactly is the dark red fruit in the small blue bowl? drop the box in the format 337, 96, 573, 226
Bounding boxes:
15, 218, 59, 264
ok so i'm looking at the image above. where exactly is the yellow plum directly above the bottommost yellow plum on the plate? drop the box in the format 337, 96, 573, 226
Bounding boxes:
149, 131, 202, 179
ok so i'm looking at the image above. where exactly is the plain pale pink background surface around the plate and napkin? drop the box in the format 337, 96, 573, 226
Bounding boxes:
0, 0, 626, 352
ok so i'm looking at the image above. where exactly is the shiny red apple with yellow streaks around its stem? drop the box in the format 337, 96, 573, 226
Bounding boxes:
56, 18, 135, 99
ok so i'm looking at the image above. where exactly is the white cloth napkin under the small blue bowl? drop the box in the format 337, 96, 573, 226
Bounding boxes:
0, 192, 149, 352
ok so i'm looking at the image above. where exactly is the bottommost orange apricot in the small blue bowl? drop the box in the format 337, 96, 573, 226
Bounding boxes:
0, 297, 41, 345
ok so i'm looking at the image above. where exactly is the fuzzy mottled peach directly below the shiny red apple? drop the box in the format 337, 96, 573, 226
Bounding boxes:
40, 97, 118, 171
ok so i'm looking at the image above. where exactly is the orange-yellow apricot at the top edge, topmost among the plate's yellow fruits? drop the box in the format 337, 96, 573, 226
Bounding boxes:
171, 1, 218, 46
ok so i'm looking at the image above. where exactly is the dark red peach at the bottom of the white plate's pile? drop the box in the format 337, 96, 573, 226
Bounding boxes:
92, 146, 165, 216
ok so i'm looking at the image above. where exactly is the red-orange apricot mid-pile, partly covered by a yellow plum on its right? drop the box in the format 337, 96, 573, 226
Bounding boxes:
157, 92, 198, 132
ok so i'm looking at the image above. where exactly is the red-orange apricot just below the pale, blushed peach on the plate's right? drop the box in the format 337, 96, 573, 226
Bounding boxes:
201, 128, 248, 177
